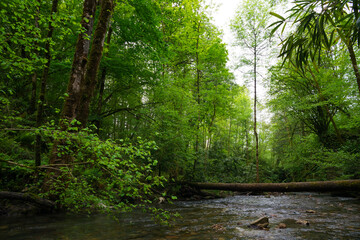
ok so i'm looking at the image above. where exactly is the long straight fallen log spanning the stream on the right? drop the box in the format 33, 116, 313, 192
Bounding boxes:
189, 179, 360, 192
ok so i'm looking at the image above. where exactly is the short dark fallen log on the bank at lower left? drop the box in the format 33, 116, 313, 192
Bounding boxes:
0, 191, 56, 209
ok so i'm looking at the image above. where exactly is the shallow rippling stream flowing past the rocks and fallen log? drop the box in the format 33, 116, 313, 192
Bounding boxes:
0, 193, 360, 240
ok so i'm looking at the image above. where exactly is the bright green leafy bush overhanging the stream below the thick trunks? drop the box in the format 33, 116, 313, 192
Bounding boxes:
36, 123, 165, 215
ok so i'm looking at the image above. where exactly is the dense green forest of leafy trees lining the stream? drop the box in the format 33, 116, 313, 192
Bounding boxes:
0, 0, 360, 212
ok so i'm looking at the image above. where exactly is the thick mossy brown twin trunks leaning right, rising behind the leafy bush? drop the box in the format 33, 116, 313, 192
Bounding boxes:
50, 0, 114, 172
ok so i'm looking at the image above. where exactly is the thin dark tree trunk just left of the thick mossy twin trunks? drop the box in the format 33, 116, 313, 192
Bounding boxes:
35, 0, 58, 166
